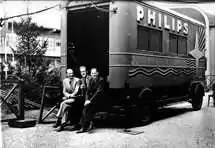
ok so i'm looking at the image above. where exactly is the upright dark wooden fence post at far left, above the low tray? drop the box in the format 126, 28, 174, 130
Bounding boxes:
18, 80, 25, 120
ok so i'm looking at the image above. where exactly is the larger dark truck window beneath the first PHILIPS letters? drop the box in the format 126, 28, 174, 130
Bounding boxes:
137, 26, 162, 52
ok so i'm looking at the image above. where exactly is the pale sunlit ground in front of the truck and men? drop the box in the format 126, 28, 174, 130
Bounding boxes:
2, 92, 215, 148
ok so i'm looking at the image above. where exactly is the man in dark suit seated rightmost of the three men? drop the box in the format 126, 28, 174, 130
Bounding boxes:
77, 68, 104, 133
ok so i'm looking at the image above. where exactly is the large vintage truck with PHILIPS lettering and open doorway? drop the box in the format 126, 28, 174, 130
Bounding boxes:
61, 1, 206, 122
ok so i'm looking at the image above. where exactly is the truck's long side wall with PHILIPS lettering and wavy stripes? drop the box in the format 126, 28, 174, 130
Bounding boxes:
109, 2, 205, 93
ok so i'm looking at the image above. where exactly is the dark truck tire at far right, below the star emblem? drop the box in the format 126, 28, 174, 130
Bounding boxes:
192, 84, 204, 111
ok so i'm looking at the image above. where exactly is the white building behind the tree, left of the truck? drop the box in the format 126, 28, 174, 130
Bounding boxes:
0, 22, 61, 63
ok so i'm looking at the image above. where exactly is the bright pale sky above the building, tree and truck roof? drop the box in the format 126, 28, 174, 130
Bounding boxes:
0, 0, 215, 29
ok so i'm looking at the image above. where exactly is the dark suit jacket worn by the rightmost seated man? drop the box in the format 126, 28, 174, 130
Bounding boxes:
86, 77, 104, 102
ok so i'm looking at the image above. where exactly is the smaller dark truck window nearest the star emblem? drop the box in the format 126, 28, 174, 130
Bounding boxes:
169, 33, 187, 55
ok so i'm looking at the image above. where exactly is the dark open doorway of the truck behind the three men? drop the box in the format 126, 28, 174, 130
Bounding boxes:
67, 6, 109, 78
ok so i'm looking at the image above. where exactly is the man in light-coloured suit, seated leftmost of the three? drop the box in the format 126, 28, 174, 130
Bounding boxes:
53, 69, 79, 131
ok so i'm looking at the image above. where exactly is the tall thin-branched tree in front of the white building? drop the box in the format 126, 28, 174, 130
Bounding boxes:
14, 17, 48, 72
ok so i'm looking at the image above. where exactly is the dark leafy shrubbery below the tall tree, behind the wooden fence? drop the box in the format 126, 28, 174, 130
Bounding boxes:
8, 60, 61, 103
